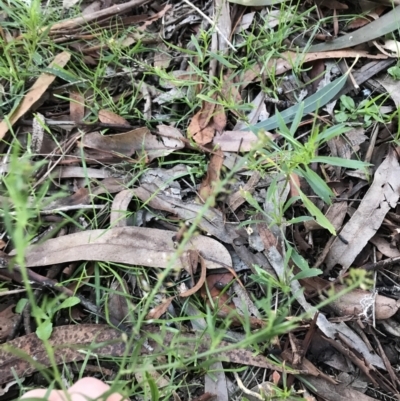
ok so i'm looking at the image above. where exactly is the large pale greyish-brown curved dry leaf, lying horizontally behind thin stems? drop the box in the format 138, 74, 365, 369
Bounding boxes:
22, 227, 232, 269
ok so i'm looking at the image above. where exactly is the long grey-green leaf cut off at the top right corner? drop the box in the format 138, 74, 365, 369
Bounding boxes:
307, 6, 400, 52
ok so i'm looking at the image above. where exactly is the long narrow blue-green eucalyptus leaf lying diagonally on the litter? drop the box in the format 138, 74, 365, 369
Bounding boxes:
244, 74, 347, 134
